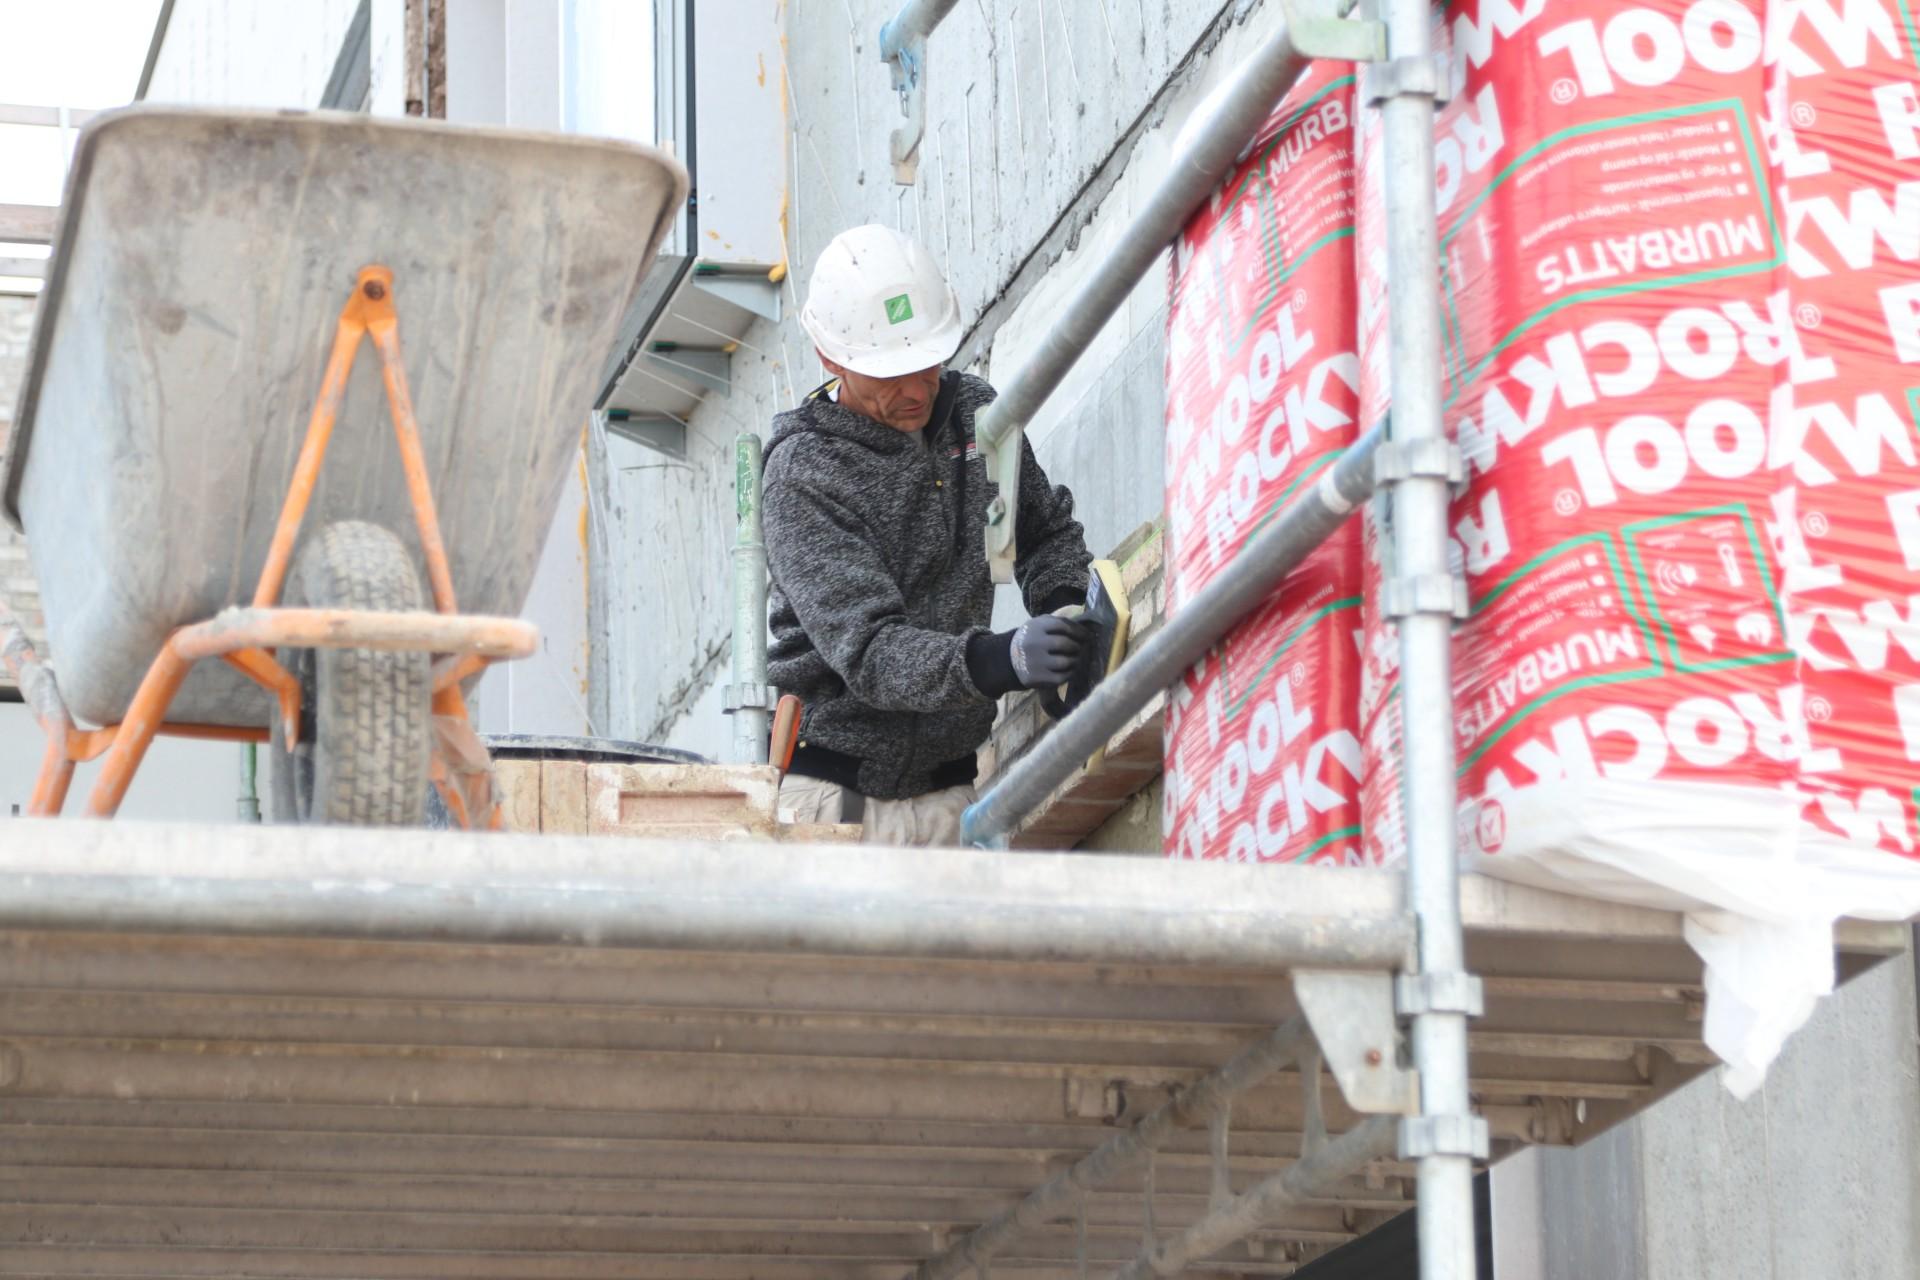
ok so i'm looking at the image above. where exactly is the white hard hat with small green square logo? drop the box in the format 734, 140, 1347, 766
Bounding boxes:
801, 225, 960, 378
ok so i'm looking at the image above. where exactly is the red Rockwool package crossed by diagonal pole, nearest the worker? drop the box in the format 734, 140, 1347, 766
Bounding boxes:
1164, 63, 1361, 864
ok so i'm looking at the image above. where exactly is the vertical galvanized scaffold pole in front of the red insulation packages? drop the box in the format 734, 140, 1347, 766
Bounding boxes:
1365, 0, 1486, 1280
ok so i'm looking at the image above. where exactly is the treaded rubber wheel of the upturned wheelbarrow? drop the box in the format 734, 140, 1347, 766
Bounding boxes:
269, 520, 432, 827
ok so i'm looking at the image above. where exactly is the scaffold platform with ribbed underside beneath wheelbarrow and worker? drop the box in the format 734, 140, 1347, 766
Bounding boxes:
0, 821, 1905, 1280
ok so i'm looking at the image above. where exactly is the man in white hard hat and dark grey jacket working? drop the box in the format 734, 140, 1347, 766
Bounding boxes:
764, 226, 1091, 844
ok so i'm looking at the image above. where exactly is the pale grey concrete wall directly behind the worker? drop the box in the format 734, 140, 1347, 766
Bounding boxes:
595, 0, 1279, 748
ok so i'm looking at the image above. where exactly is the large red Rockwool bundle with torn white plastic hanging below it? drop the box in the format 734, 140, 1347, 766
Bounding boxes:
1357, 0, 1920, 1092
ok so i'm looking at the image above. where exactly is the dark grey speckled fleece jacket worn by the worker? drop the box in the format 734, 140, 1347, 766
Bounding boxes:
764, 372, 1091, 800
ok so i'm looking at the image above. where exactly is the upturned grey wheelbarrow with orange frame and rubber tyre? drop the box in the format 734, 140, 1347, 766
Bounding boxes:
0, 107, 687, 825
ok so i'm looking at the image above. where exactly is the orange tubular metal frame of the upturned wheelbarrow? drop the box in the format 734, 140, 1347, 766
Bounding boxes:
0, 265, 540, 829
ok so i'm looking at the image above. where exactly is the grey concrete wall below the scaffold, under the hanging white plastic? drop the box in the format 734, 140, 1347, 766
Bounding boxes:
1494, 940, 1920, 1280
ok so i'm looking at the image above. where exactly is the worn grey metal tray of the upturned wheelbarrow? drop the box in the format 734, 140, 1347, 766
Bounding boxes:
0, 107, 687, 727
